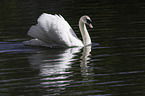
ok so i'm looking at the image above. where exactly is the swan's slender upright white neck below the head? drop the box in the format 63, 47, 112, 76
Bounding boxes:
79, 20, 91, 46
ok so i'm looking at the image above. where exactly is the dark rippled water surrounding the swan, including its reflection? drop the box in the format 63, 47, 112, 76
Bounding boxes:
0, 0, 145, 96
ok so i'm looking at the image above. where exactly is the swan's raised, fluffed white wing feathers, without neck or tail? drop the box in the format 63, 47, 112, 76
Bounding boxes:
28, 13, 83, 47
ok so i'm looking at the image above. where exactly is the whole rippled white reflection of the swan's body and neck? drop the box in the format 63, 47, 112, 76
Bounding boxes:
29, 46, 91, 87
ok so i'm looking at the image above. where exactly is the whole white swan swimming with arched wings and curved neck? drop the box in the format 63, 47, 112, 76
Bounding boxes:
23, 13, 93, 47
